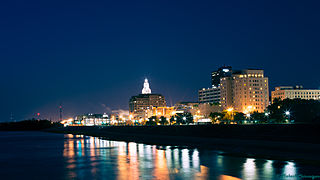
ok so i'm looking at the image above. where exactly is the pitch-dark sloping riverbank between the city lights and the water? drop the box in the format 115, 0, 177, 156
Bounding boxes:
49, 124, 320, 164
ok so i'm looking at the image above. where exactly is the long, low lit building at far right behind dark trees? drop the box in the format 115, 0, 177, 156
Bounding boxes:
271, 86, 320, 102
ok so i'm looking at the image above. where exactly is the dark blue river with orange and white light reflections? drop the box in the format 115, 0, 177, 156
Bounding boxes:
0, 132, 320, 180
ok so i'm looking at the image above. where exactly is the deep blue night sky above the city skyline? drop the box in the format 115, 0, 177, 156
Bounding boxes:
0, 0, 320, 121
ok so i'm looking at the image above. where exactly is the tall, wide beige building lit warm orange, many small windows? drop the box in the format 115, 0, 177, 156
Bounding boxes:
220, 69, 269, 113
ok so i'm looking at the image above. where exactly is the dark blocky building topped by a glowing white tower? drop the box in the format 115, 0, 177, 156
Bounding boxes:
129, 79, 166, 119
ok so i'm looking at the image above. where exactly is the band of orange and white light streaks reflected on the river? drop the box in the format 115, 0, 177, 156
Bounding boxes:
63, 134, 298, 180
